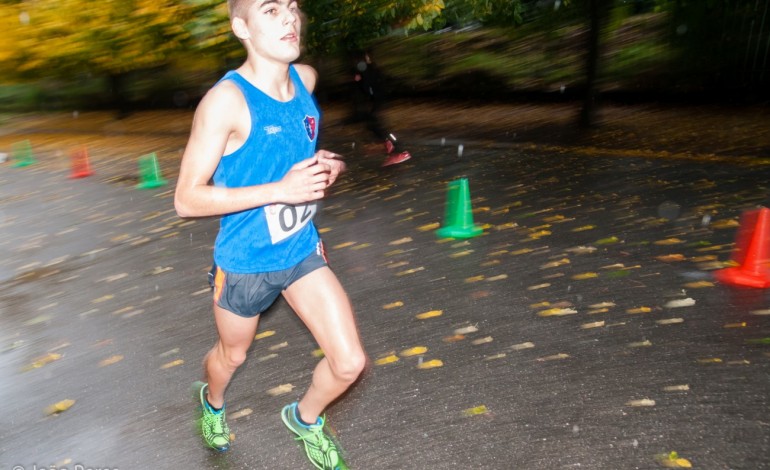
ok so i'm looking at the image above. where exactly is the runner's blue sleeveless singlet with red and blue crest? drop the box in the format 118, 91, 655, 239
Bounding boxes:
213, 66, 320, 274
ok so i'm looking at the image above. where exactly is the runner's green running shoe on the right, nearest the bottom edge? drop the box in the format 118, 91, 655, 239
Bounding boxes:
281, 402, 349, 470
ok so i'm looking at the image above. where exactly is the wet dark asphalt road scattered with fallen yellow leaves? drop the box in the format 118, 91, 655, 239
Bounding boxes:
0, 137, 770, 470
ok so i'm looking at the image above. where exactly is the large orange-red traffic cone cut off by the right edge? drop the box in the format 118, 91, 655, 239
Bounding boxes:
714, 207, 770, 288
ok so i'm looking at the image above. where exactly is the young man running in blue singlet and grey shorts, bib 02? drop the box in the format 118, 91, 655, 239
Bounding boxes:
174, 0, 366, 469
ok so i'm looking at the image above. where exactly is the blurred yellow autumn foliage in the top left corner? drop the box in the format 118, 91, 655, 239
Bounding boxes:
0, 0, 198, 75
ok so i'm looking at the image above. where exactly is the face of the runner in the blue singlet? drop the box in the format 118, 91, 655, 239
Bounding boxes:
246, 0, 302, 63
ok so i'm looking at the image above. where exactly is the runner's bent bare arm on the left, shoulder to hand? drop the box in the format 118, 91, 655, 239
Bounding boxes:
174, 82, 332, 217
